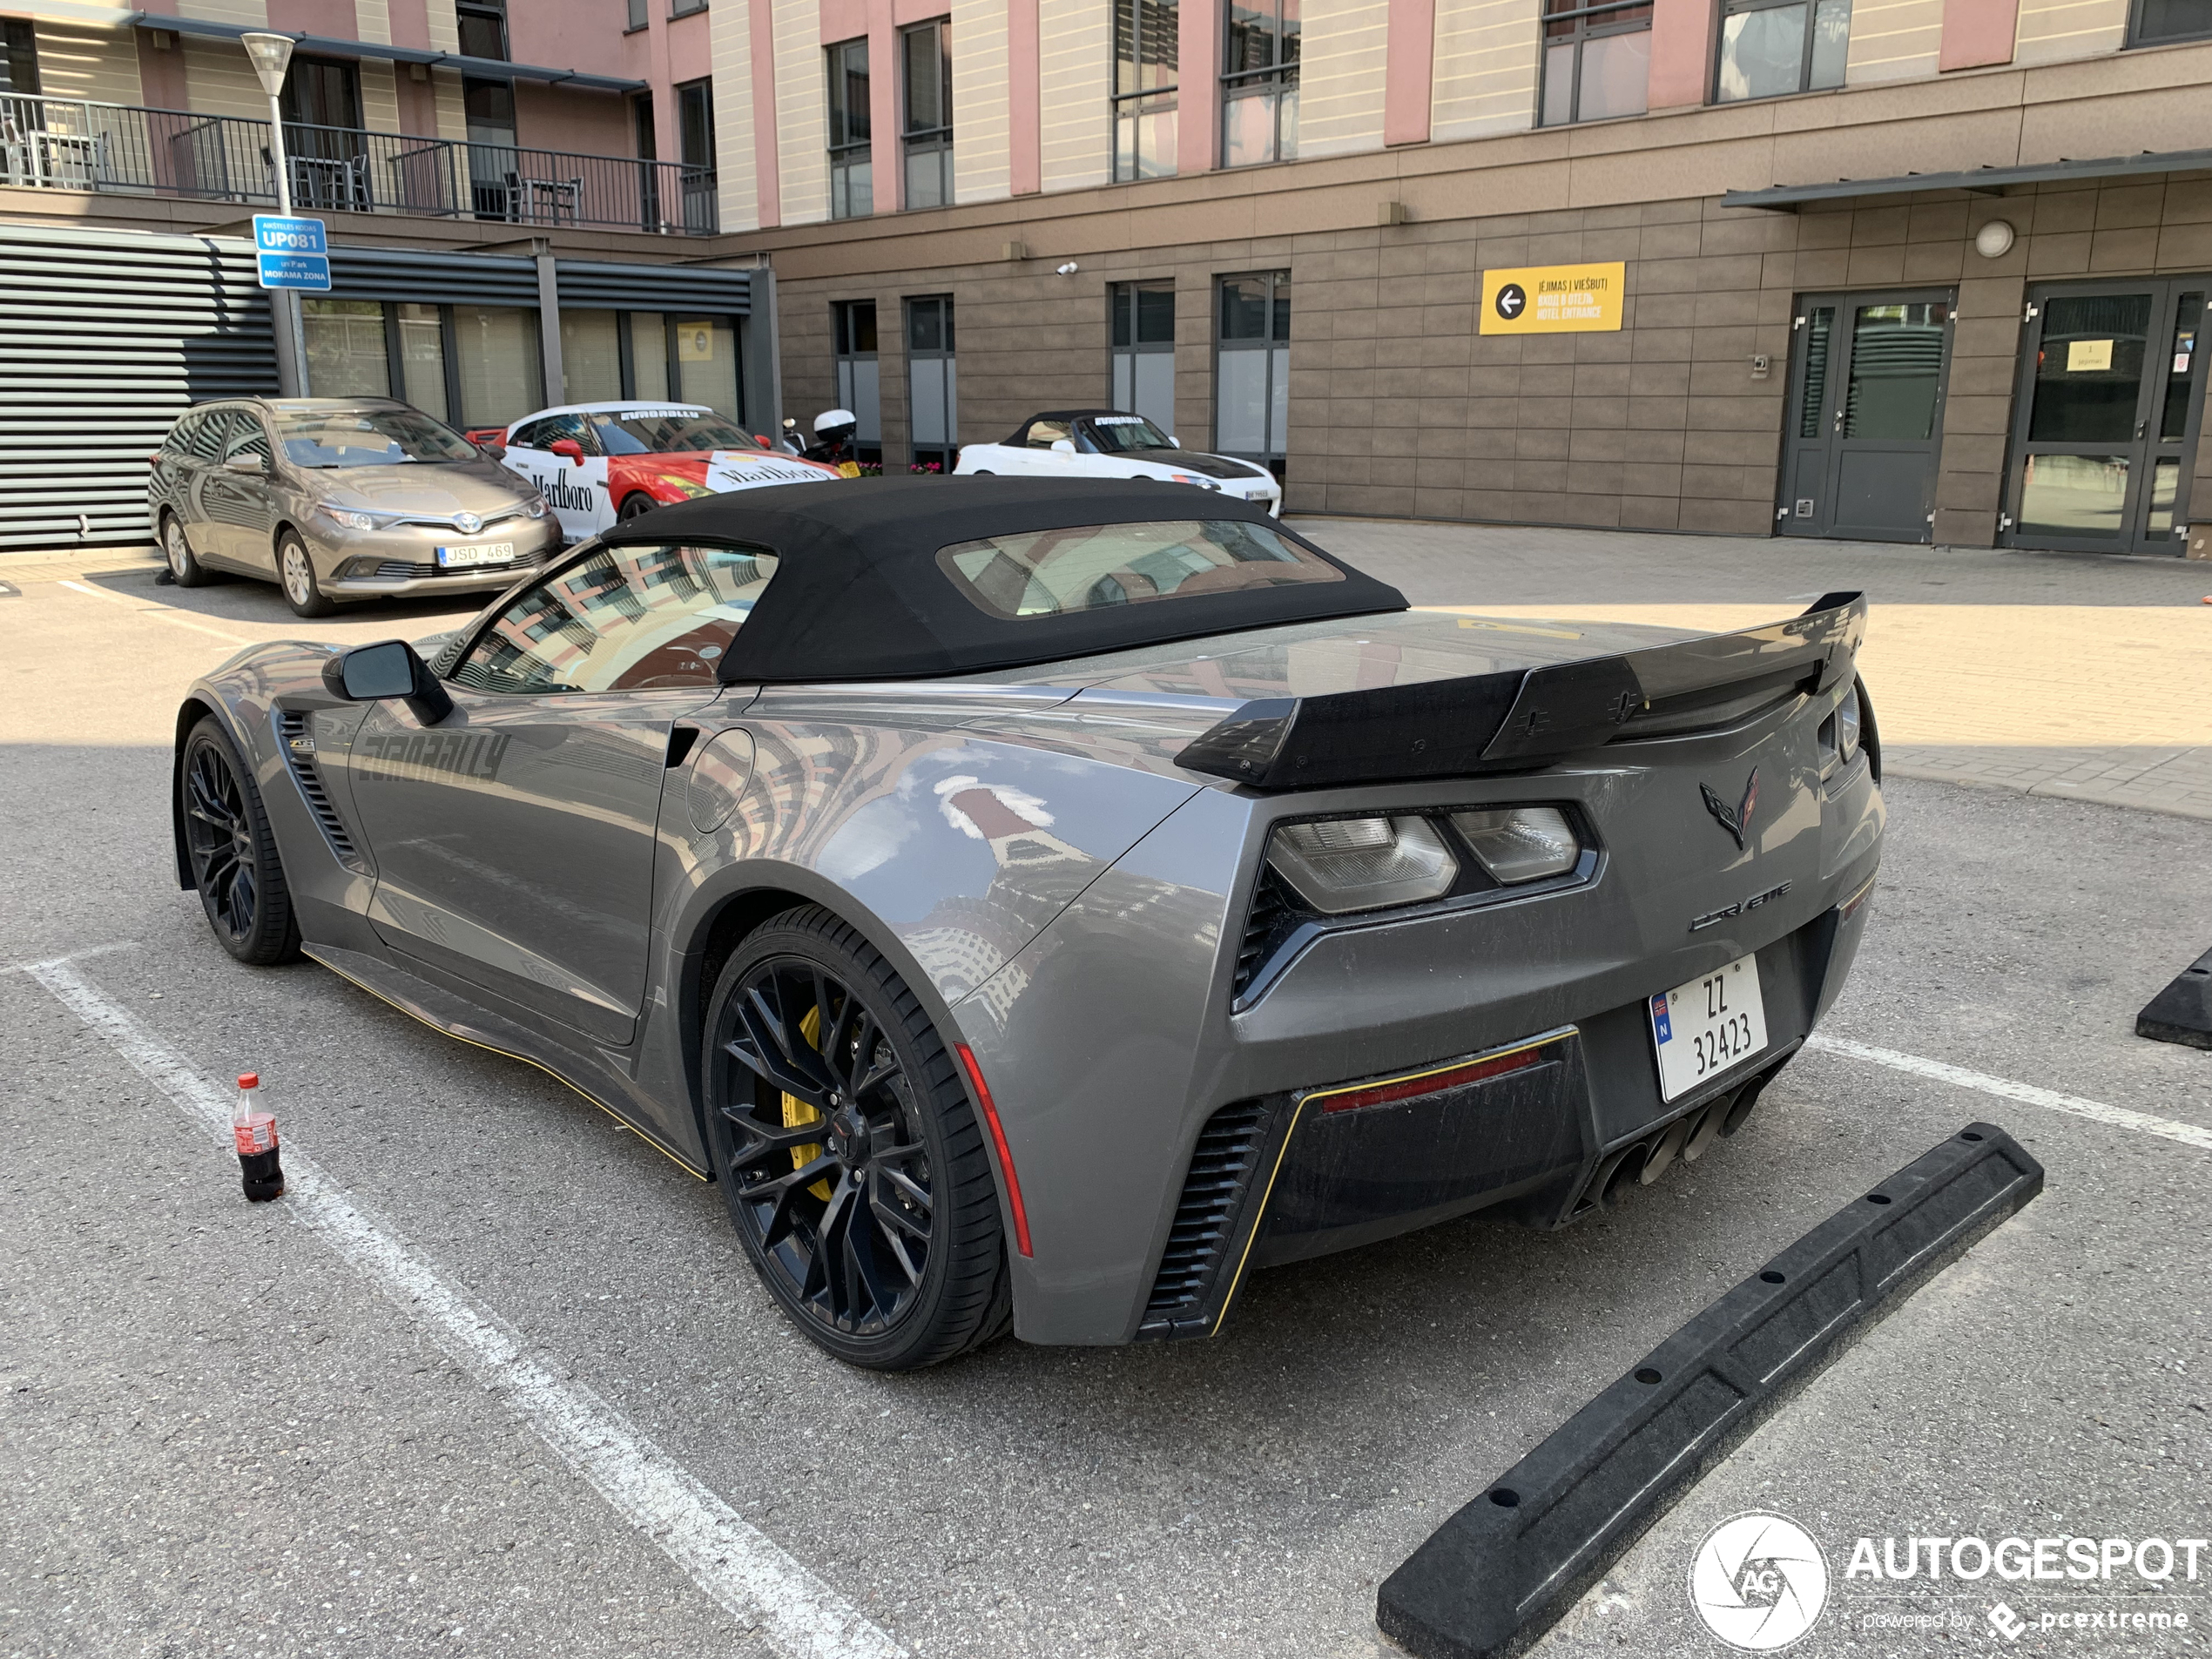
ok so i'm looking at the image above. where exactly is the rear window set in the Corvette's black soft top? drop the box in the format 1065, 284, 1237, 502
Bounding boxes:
938, 517, 1345, 622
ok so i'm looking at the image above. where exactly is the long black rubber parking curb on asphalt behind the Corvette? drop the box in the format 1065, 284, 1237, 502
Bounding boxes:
1376, 1123, 2044, 1659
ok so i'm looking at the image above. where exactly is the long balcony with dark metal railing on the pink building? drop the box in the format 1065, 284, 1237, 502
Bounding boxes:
0, 93, 719, 237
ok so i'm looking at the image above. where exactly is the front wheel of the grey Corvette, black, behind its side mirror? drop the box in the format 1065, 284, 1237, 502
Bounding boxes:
177, 714, 299, 967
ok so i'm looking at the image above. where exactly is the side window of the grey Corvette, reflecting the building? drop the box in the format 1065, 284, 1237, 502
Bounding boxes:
454, 546, 777, 697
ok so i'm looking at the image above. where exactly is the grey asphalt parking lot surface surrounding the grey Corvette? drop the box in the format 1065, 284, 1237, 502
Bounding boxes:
0, 535, 2212, 1659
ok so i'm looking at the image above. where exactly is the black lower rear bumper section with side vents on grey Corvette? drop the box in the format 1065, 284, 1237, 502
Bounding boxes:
1137, 907, 1867, 1340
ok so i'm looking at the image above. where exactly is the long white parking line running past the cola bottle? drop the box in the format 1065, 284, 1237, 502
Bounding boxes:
22, 958, 905, 1659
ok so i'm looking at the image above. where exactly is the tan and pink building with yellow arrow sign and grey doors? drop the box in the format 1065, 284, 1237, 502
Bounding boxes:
710, 0, 2212, 553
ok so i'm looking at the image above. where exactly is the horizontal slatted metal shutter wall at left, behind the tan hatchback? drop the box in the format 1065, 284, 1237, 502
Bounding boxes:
0, 226, 277, 546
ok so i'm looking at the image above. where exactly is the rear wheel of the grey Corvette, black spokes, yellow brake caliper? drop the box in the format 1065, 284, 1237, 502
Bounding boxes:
701, 905, 1011, 1372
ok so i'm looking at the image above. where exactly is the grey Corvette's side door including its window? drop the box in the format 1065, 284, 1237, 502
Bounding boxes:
332, 546, 774, 1046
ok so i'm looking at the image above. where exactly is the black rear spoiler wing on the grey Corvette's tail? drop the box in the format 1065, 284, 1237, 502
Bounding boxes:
1175, 593, 1867, 790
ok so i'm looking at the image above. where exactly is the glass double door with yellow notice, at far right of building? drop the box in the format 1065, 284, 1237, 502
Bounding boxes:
2000, 277, 2212, 553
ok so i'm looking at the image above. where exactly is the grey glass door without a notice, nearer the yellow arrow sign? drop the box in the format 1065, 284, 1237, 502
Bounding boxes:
1774, 290, 1953, 542
